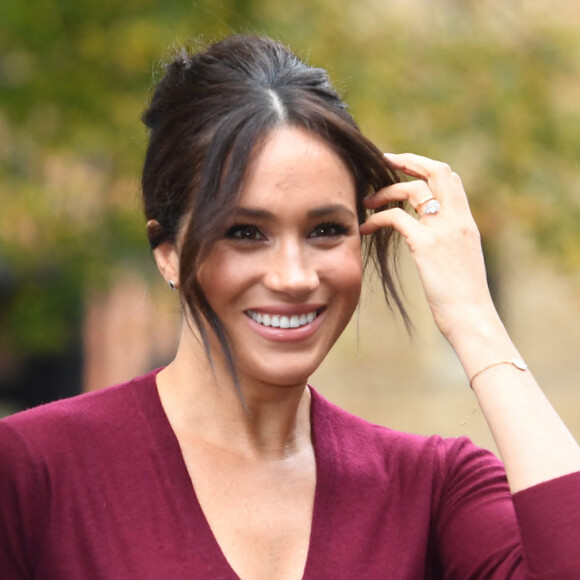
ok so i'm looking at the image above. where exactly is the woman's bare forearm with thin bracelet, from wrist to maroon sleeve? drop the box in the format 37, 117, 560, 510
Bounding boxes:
449, 314, 580, 492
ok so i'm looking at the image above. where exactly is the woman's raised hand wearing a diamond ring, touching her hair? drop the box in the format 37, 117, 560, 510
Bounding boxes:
360, 153, 498, 343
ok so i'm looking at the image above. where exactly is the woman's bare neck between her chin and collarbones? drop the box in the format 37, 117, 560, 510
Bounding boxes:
157, 322, 311, 458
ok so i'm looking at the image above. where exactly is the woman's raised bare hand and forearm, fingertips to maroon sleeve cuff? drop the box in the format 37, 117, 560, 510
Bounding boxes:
361, 154, 580, 492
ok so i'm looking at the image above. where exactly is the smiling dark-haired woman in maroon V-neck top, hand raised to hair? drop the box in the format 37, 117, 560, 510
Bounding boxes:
0, 36, 580, 580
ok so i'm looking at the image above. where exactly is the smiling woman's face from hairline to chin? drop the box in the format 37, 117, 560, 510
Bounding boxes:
199, 128, 362, 386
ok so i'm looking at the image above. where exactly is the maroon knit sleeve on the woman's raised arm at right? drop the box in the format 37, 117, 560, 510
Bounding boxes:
434, 439, 580, 580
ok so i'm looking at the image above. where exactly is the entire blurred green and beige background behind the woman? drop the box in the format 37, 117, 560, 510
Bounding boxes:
0, 0, 580, 449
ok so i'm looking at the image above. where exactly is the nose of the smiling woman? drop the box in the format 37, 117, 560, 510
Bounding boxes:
264, 241, 319, 297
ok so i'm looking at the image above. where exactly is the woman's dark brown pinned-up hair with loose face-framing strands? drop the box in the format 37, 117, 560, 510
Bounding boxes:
142, 35, 407, 385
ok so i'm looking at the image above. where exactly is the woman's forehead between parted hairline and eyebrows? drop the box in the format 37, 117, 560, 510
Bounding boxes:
238, 127, 356, 207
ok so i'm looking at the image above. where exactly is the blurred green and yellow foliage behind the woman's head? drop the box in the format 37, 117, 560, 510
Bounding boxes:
0, 0, 580, 352
